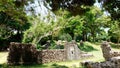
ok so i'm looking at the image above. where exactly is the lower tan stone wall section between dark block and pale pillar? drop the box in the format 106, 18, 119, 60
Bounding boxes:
38, 49, 66, 63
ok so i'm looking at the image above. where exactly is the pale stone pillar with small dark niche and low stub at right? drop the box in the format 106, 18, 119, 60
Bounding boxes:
64, 41, 93, 60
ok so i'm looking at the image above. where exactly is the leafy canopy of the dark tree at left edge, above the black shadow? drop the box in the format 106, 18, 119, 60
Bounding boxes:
0, 0, 29, 39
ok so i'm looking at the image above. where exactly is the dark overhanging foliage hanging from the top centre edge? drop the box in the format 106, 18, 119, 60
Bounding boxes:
47, 0, 95, 15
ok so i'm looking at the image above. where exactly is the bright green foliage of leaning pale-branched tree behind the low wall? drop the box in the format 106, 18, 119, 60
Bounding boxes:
23, 11, 82, 44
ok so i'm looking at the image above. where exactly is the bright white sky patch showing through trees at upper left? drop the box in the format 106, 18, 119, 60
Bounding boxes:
26, 0, 56, 22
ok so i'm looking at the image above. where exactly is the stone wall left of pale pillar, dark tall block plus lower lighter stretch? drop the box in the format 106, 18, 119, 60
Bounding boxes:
7, 42, 67, 65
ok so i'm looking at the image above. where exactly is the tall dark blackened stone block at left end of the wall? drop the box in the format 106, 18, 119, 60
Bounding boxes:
7, 42, 37, 65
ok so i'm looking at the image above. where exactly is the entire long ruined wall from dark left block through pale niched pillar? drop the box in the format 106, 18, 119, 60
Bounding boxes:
7, 42, 92, 65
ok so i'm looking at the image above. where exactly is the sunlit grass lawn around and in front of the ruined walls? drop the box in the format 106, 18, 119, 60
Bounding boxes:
0, 42, 118, 68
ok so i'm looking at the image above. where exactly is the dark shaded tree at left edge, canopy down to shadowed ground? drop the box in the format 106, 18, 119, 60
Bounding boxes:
0, 0, 30, 49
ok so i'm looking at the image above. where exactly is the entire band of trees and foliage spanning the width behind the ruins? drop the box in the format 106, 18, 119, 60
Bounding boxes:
0, 0, 120, 50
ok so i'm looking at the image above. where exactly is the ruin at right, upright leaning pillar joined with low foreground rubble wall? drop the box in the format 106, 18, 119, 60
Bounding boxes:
81, 42, 120, 68
